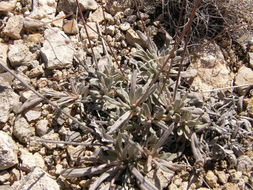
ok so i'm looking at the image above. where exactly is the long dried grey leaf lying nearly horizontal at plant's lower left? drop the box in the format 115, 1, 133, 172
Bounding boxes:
61, 162, 118, 179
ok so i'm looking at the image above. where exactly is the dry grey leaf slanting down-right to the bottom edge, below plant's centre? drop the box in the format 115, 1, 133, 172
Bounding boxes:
129, 166, 159, 190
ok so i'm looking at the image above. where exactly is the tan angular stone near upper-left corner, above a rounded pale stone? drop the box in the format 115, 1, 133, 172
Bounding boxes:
3, 15, 24, 40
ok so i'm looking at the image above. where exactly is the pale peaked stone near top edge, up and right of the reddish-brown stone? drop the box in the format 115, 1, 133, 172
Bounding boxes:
88, 7, 114, 23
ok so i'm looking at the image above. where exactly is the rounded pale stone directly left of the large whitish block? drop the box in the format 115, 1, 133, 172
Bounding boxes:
8, 44, 35, 67
